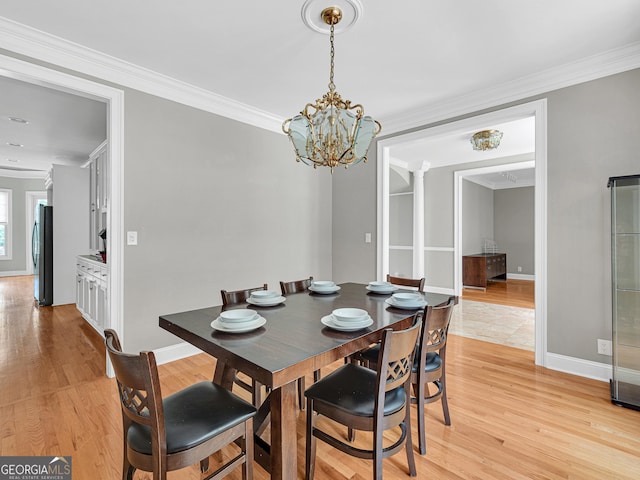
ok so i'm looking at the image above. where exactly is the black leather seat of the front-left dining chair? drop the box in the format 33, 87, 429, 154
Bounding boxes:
128, 382, 256, 455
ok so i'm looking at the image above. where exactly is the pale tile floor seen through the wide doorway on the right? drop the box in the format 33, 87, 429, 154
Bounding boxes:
449, 299, 535, 351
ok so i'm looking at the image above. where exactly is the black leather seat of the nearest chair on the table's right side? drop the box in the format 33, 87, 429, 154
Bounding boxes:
305, 363, 406, 417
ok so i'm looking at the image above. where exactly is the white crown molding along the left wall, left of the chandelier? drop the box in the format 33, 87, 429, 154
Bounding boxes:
0, 17, 282, 133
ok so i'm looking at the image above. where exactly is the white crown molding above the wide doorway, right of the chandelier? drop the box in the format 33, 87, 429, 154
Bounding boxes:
381, 42, 640, 136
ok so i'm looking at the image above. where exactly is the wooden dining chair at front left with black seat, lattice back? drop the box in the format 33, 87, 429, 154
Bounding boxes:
104, 329, 256, 480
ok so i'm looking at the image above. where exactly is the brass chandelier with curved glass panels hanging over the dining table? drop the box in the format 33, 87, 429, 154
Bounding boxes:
282, 7, 382, 173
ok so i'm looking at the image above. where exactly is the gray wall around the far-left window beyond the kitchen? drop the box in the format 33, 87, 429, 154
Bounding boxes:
0, 177, 44, 272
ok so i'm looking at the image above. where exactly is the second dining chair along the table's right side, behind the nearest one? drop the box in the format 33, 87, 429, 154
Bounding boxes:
359, 296, 458, 455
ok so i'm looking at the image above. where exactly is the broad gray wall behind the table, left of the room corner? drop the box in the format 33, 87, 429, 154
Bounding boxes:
124, 90, 332, 351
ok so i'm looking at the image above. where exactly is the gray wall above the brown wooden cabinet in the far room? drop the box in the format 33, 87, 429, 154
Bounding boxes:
493, 187, 535, 275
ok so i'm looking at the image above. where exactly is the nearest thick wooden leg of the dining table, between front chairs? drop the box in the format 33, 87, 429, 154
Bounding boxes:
271, 381, 298, 480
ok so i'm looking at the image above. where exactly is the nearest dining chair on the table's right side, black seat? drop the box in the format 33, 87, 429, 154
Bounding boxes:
305, 316, 421, 480
